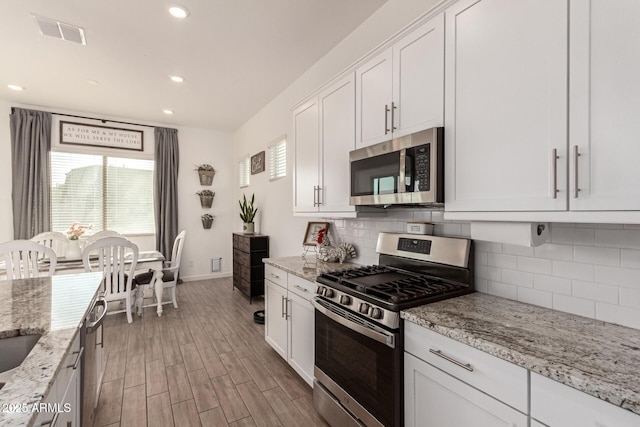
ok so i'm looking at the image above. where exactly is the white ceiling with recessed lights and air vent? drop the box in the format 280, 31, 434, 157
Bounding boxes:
0, 0, 386, 131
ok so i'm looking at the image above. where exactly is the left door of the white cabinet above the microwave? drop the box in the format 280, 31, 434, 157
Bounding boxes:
356, 48, 393, 148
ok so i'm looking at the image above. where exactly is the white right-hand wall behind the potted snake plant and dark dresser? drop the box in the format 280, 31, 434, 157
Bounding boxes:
233, 0, 444, 257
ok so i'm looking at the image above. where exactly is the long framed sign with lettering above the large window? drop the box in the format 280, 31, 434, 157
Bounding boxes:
60, 121, 144, 151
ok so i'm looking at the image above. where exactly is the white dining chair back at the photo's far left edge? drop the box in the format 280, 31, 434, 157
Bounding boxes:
0, 240, 58, 280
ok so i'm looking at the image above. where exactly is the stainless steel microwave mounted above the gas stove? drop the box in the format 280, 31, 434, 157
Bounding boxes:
349, 127, 444, 207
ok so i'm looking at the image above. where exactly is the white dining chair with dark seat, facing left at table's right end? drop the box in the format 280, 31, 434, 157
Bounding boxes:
136, 230, 187, 316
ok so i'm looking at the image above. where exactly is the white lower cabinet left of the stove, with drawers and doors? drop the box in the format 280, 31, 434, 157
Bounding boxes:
264, 265, 315, 386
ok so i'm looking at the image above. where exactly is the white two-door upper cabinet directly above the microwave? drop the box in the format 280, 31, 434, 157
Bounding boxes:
356, 15, 444, 148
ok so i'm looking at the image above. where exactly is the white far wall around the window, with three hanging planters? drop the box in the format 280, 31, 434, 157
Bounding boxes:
0, 100, 235, 281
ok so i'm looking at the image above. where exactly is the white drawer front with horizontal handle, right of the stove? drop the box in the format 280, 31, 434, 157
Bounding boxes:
405, 322, 528, 413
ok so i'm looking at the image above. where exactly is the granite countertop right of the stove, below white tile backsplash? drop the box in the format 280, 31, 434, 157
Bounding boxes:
402, 293, 640, 414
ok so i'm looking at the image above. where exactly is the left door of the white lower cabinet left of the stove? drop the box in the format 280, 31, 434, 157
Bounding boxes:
264, 280, 287, 360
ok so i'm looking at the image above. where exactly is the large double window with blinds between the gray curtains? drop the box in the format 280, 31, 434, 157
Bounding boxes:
51, 151, 155, 234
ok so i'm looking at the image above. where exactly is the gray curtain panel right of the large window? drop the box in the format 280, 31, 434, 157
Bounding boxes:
153, 128, 180, 259
